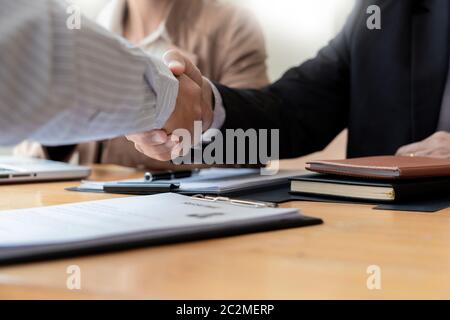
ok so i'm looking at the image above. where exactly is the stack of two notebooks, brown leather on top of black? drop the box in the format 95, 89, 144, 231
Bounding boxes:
291, 156, 450, 202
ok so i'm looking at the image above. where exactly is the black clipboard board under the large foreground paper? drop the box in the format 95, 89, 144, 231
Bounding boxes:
0, 196, 323, 265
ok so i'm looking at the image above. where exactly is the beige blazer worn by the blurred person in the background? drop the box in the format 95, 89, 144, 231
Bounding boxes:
15, 0, 269, 169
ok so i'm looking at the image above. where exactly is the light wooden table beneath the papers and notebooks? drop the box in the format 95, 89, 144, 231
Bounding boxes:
0, 166, 450, 299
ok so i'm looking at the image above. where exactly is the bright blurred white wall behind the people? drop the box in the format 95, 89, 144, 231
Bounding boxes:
75, 0, 354, 80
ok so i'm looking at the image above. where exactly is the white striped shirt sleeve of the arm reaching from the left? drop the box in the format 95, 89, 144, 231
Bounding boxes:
0, 0, 178, 146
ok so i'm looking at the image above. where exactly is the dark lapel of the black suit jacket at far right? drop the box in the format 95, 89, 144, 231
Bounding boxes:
411, 0, 450, 141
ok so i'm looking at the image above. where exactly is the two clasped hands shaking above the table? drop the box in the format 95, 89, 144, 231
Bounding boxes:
127, 50, 214, 161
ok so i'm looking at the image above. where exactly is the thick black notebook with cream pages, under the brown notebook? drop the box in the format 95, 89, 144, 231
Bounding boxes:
291, 174, 450, 202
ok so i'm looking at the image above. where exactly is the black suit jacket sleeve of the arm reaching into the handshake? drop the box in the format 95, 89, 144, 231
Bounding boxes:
217, 1, 363, 158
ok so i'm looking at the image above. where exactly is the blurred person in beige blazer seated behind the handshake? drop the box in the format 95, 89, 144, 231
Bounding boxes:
15, 0, 269, 170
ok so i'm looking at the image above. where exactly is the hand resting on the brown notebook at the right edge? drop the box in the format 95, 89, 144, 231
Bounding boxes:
397, 131, 450, 159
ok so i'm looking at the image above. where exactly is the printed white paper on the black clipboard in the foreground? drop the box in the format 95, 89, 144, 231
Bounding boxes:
0, 194, 298, 248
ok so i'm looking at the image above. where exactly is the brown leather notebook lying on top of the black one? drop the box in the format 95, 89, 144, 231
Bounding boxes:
306, 156, 450, 179
